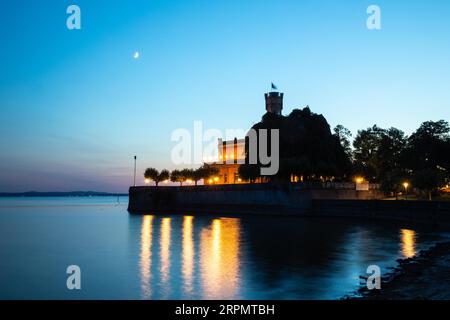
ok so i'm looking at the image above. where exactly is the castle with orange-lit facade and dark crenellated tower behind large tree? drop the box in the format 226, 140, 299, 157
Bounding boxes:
204, 91, 284, 184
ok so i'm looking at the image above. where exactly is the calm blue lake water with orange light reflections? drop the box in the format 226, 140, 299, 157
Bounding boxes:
0, 197, 447, 299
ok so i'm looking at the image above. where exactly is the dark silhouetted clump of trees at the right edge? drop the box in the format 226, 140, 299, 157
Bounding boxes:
353, 120, 450, 199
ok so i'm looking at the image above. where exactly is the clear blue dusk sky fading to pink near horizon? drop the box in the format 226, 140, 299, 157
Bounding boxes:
0, 0, 450, 192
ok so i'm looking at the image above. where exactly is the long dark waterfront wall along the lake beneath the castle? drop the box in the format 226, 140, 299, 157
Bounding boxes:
128, 184, 450, 226
